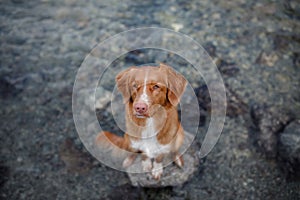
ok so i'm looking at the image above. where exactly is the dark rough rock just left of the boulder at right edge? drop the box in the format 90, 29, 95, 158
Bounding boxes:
250, 105, 293, 158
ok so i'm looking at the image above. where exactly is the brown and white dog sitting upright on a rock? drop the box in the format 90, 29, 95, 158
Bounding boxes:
97, 64, 187, 179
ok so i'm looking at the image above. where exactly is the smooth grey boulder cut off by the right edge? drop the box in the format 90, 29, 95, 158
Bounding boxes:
278, 120, 300, 179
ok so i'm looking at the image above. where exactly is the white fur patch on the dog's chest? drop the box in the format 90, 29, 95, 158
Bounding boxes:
131, 118, 170, 158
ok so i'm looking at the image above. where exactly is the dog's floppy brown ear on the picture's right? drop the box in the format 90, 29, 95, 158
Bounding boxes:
159, 63, 187, 106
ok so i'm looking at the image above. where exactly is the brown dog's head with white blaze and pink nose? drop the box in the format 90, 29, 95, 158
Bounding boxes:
116, 64, 187, 118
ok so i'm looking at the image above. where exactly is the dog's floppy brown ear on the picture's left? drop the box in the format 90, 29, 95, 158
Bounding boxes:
116, 67, 133, 103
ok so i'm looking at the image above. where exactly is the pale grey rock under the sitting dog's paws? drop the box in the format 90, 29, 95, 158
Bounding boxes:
128, 132, 201, 188
